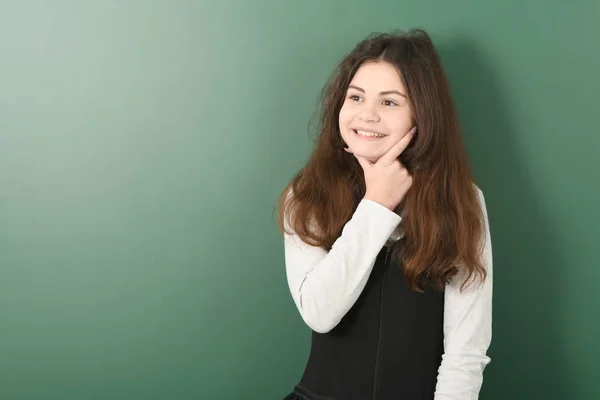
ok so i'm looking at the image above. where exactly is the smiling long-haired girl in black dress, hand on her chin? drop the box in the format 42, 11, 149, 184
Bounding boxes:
279, 30, 492, 400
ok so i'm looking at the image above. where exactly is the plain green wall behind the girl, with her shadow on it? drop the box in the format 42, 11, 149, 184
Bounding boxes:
0, 0, 600, 400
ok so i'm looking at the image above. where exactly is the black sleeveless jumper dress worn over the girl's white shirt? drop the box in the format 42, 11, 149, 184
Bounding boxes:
284, 239, 444, 400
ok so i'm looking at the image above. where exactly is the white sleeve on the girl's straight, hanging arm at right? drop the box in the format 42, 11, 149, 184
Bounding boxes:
435, 188, 493, 400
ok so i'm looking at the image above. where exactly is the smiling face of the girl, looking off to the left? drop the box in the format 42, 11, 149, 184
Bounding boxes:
339, 61, 413, 162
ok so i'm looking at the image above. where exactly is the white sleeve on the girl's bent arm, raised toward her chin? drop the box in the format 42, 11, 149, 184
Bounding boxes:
284, 199, 401, 333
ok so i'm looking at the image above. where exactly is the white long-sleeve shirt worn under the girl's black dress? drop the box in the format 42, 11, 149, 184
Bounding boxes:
284, 188, 493, 400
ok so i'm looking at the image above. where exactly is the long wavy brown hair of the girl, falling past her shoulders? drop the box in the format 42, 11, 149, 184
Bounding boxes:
278, 29, 486, 291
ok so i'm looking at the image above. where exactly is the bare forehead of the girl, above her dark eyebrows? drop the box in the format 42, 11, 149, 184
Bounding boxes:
350, 61, 404, 92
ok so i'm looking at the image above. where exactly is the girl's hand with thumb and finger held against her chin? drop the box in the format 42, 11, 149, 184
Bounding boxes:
346, 127, 416, 211
